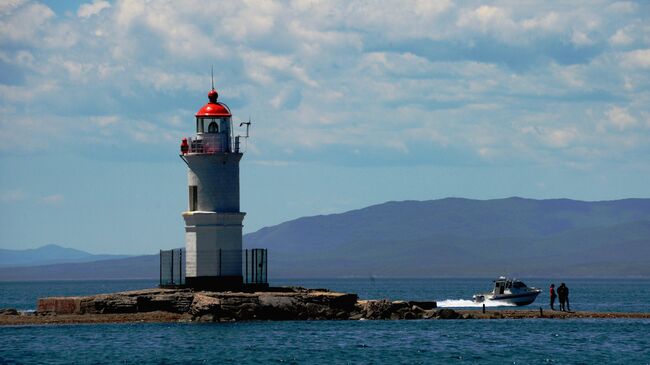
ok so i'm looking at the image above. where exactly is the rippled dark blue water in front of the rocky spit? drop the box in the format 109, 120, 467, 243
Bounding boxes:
0, 319, 650, 364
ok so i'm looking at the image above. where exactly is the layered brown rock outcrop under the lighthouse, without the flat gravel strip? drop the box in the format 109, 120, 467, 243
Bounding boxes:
24, 287, 440, 322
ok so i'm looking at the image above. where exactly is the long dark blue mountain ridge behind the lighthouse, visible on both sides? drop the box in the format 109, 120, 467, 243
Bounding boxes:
0, 198, 650, 280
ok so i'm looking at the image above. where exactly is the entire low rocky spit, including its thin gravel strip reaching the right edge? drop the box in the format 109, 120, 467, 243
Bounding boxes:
0, 287, 650, 326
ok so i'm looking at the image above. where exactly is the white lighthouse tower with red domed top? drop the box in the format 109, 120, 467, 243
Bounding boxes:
181, 87, 247, 290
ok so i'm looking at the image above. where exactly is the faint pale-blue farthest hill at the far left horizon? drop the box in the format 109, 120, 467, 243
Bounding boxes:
0, 245, 129, 267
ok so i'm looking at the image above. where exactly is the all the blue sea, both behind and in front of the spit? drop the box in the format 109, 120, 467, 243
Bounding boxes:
0, 277, 650, 364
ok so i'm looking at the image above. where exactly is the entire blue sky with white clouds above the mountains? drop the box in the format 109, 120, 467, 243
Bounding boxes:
0, 0, 650, 254
